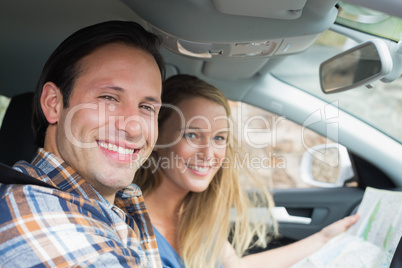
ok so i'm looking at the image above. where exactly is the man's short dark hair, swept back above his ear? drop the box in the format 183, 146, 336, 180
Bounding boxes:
33, 21, 165, 147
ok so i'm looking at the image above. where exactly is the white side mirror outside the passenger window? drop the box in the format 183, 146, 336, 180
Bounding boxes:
300, 143, 354, 188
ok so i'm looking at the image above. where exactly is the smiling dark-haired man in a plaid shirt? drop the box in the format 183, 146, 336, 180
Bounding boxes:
0, 21, 164, 267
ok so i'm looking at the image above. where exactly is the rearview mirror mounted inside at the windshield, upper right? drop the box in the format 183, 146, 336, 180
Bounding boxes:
320, 40, 392, 94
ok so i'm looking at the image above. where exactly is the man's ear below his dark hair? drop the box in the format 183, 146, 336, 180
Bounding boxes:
40, 82, 63, 124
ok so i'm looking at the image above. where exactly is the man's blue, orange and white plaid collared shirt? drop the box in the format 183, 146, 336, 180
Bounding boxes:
0, 149, 162, 267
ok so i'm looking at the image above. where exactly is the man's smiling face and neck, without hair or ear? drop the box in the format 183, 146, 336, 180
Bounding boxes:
50, 44, 162, 200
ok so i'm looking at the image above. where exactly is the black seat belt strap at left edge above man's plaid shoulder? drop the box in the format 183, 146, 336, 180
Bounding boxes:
0, 163, 58, 189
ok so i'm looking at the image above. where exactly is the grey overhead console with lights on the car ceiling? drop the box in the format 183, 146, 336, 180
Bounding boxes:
122, 0, 338, 60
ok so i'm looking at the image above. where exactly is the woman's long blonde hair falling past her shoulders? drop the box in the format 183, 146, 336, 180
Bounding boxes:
134, 75, 277, 268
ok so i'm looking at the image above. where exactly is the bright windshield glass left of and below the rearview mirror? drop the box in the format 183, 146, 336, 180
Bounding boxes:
272, 28, 402, 143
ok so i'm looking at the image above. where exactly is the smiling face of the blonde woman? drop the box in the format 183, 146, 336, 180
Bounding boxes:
155, 97, 229, 193
